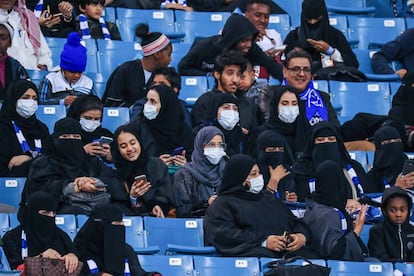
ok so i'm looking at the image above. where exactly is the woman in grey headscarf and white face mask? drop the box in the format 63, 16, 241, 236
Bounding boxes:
174, 126, 226, 217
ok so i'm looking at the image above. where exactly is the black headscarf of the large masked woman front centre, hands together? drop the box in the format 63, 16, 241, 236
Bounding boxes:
219, 154, 263, 200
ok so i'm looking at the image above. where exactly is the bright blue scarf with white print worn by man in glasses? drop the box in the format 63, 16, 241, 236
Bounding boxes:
282, 79, 328, 126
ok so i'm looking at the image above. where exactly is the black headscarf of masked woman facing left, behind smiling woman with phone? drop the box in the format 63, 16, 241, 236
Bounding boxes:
144, 85, 193, 153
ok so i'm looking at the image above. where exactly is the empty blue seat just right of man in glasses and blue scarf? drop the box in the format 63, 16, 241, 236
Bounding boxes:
329, 81, 391, 117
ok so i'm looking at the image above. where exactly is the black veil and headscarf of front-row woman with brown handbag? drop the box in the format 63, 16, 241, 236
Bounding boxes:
18, 191, 67, 257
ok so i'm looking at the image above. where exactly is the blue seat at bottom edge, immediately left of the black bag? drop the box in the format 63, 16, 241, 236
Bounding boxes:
193, 256, 261, 276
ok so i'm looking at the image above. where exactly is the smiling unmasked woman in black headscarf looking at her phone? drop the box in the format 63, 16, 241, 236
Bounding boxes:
111, 125, 173, 218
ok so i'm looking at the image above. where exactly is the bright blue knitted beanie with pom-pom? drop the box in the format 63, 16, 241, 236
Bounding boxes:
60, 32, 86, 72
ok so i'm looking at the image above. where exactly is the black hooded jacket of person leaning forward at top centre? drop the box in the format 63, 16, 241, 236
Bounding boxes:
178, 14, 283, 81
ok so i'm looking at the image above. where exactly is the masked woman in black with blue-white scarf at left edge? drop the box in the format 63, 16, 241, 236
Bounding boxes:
0, 80, 51, 177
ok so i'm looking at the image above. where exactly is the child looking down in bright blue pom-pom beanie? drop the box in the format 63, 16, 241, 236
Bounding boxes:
39, 32, 96, 106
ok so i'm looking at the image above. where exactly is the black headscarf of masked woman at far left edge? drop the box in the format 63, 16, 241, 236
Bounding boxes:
0, 80, 49, 139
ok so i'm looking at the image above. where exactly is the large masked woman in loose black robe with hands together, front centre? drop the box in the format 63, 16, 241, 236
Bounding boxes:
204, 154, 315, 258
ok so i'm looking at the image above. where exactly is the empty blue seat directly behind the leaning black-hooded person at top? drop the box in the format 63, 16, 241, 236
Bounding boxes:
175, 10, 231, 44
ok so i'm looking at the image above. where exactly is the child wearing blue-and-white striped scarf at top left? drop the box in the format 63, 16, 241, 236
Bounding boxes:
78, 0, 121, 40
